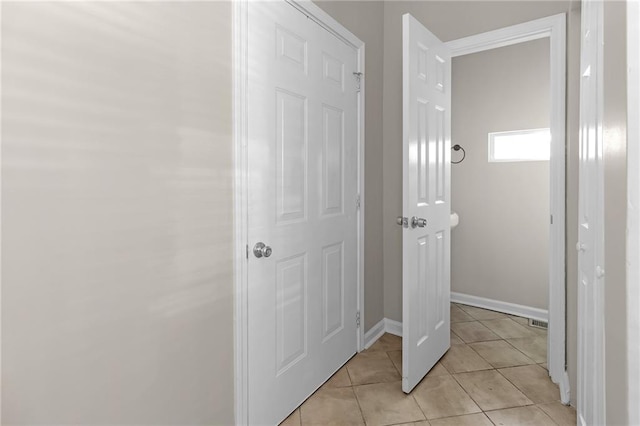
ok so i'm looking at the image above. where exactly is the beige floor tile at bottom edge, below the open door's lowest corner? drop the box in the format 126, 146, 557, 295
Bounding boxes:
353, 381, 426, 426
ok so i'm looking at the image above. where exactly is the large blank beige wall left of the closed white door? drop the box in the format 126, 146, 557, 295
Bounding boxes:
1, 2, 234, 425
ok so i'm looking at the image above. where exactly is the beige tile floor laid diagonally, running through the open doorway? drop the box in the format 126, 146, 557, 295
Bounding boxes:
282, 304, 576, 426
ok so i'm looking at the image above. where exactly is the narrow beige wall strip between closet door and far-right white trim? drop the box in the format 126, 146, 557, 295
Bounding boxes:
603, 1, 628, 425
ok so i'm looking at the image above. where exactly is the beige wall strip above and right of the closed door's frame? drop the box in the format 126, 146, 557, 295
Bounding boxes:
316, 1, 384, 331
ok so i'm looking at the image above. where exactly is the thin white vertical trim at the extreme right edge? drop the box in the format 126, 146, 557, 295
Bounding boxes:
627, 1, 640, 425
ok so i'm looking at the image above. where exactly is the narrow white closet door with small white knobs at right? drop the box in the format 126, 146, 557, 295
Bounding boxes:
576, 0, 605, 425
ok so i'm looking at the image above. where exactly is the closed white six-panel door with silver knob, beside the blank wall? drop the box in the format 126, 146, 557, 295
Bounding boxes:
247, 1, 358, 425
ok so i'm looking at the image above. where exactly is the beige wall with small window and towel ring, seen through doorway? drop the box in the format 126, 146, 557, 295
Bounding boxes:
451, 38, 550, 310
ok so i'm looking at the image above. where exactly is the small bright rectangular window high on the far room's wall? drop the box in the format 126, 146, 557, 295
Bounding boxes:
489, 129, 551, 163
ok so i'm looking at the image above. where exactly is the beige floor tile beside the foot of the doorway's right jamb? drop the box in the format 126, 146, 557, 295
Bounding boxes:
498, 365, 560, 404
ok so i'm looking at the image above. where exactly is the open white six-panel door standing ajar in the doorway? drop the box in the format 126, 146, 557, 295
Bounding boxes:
402, 14, 451, 393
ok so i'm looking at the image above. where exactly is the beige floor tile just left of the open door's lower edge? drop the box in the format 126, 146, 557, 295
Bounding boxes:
347, 351, 402, 385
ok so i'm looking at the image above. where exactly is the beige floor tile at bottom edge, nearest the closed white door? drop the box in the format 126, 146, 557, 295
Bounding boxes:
300, 387, 364, 426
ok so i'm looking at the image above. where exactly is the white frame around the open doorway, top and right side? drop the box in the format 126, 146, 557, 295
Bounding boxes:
447, 13, 570, 404
